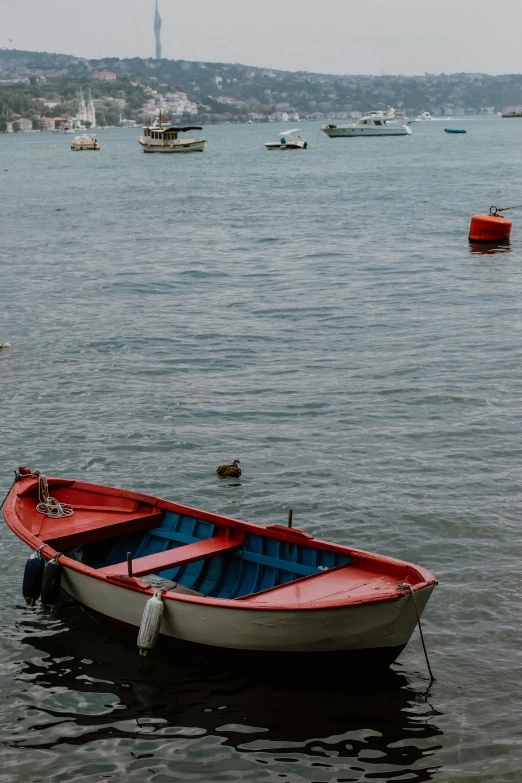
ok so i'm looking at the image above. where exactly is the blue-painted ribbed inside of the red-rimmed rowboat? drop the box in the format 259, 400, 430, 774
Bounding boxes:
82, 511, 350, 599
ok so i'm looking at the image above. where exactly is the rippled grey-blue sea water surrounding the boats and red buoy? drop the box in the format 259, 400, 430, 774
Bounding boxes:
0, 117, 522, 783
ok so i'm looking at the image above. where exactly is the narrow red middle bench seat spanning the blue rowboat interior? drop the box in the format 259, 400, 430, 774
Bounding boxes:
96, 536, 243, 576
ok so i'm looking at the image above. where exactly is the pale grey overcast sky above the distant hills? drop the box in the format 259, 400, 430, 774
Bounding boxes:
0, 0, 522, 74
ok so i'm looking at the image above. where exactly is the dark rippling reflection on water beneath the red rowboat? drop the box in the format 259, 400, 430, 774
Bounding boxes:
7, 608, 442, 783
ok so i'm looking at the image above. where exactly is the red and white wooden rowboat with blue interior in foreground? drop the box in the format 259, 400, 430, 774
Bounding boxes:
4, 468, 437, 664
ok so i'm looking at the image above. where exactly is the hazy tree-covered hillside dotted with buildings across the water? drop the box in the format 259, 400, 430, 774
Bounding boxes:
0, 50, 522, 125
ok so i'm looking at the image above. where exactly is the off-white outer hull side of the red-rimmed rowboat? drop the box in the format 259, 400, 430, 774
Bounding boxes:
62, 561, 433, 654
